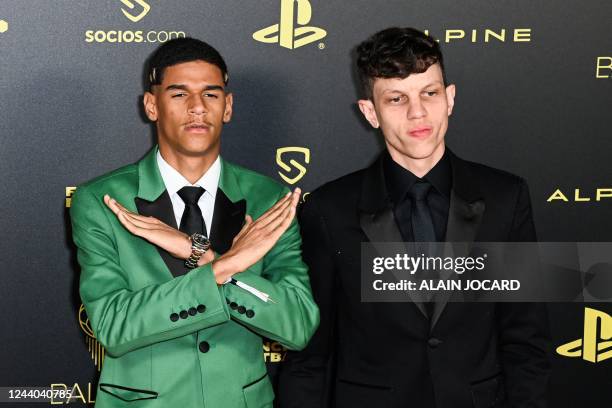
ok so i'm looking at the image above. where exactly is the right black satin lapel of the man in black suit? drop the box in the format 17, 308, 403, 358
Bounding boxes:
431, 150, 485, 329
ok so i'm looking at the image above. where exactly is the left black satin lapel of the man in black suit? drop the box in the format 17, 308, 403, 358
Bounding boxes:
359, 153, 427, 317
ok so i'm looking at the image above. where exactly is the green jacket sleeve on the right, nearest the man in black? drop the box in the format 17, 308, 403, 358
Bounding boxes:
224, 190, 319, 350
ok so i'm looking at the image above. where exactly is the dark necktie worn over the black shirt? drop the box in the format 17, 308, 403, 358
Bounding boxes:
408, 181, 438, 318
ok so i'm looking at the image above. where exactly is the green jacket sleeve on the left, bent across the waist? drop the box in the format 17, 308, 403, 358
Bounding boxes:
70, 187, 229, 356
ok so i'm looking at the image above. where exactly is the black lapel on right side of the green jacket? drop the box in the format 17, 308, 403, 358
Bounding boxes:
209, 188, 246, 254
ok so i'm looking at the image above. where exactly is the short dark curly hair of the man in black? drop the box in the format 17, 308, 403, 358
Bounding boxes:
357, 27, 447, 99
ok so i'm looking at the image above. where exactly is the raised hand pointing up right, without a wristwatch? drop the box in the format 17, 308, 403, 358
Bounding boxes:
212, 188, 301, 282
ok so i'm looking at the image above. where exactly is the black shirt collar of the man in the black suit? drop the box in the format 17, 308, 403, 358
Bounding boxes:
383, 149, 452, 203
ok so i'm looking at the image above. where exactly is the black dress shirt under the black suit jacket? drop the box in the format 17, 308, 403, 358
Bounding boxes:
383, 150, 453, 242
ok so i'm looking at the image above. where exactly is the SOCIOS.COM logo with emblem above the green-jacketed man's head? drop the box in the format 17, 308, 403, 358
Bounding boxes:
85, 0, 187, 44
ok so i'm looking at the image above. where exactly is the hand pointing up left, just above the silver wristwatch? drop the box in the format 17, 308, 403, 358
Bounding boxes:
104, 194, 192, 258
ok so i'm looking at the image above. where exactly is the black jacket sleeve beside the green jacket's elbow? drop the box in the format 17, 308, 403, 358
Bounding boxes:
278, 196, 336, 408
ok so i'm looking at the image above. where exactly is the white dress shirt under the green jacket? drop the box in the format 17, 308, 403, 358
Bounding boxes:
157, 150, 221, 237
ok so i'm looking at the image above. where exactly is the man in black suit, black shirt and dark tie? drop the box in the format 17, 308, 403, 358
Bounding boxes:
279, 28, 550, 408
